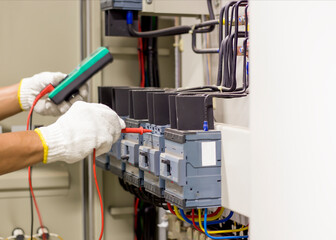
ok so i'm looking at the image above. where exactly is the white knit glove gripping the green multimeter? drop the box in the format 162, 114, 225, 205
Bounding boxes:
18, 72, 88, 116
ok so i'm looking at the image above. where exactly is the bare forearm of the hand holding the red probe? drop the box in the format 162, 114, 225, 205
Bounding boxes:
0, 131, 43, 175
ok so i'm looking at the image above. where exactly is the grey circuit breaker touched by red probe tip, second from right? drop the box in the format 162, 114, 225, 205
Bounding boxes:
139, 123, 169, 197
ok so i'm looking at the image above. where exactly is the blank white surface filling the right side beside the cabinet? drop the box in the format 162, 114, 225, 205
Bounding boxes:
250, 0, 336, 240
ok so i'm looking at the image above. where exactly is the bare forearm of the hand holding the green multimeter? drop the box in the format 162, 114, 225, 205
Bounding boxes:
0, 83, 22, 120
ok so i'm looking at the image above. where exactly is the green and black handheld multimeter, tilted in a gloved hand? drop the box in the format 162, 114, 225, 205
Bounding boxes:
48, 47, 113, 104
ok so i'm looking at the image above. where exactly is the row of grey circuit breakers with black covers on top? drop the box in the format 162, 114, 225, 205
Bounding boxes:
97, 87, 221, 209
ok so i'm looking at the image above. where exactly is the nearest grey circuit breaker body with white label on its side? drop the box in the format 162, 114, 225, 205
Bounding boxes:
160, 128, 221, 209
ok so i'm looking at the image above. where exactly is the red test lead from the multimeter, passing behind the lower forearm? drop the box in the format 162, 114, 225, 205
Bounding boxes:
27, 84, 54, 240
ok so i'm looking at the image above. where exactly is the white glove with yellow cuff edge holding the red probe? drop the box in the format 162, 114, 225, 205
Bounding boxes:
35, 101, 126, 163
